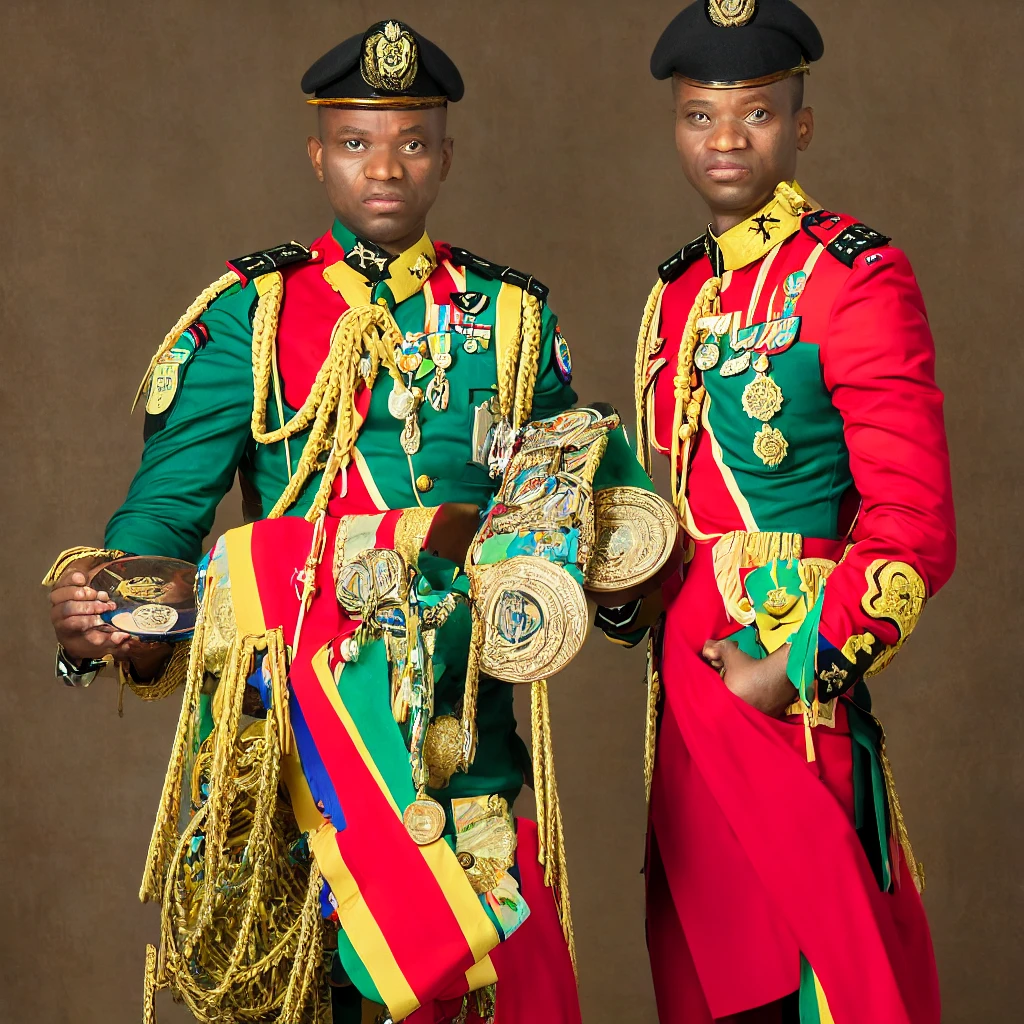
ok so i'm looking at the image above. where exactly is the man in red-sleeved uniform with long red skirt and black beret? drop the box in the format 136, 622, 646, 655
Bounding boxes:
618, 0, 955, 1024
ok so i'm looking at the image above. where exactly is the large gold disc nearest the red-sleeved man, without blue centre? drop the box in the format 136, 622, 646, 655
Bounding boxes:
587, 487, 679, 593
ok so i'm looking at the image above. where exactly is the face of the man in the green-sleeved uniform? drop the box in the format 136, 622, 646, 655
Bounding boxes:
307, 106, 454, 252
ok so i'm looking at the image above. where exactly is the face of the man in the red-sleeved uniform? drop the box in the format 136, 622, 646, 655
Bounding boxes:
673, 78, 814, 224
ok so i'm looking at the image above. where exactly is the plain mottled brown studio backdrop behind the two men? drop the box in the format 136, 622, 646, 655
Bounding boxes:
0, 0, 1024, 1024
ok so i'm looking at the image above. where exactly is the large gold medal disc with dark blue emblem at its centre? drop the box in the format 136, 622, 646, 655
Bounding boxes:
473, 555, 590, 683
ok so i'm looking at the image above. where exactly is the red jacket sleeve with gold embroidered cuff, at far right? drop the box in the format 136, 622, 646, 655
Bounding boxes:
816, 247, 956, 699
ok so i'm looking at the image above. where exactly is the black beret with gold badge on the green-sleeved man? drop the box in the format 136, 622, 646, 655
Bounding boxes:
302, 19, 465, 108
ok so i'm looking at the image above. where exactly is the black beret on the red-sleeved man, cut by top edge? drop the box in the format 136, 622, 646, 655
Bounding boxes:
650, 0, 825, 87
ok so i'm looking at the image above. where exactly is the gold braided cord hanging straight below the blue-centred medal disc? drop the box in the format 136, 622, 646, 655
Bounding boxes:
529, 679, 577, 973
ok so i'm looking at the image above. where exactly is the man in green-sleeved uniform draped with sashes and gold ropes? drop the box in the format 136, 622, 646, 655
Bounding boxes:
47, 22, 649, 1024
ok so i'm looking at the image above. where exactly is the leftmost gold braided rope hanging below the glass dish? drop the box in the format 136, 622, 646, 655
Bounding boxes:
138, 587, 213, 903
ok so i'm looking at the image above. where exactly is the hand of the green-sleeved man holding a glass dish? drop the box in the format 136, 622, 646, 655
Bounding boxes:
50, 571, 171, 679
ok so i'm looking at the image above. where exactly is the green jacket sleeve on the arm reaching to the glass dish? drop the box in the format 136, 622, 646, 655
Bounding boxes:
105, 285, 256, 561
